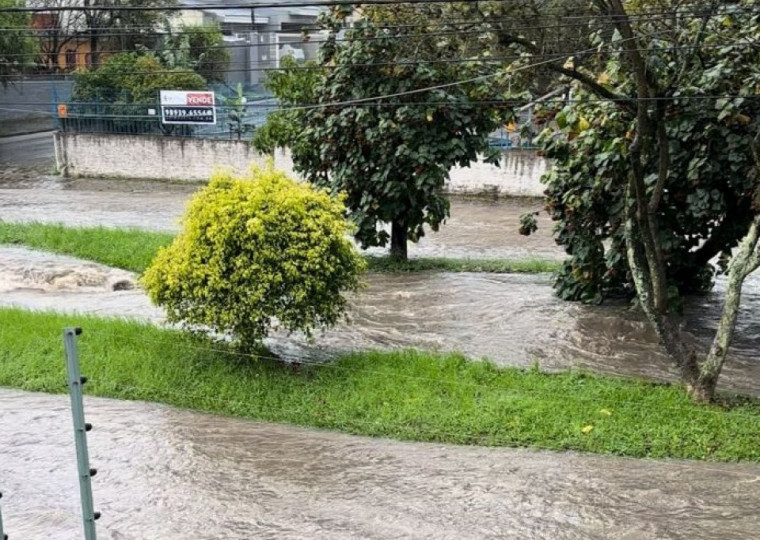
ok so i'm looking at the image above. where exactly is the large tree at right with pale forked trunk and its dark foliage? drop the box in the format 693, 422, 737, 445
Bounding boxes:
480, 0, 760, 401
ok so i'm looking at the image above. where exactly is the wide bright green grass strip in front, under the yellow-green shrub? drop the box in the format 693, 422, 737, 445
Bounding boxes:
0, 309, 760, 461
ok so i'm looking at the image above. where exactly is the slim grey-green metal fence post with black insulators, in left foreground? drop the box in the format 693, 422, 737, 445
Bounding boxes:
63, 328, 100, 540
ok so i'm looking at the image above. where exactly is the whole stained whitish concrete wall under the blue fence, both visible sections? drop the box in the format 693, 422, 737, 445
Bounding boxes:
56, 133, 548, 197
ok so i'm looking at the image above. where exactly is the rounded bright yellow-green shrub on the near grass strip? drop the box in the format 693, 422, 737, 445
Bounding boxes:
142, 166, 364, 347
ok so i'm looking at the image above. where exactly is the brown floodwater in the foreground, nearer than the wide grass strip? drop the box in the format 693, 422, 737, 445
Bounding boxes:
0, 389, 760, 540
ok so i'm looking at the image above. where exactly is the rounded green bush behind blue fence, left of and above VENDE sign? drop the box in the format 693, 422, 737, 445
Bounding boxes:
73, 53, 206, 104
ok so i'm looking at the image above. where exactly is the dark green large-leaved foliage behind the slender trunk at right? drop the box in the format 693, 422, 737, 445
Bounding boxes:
524, 1, 760, 306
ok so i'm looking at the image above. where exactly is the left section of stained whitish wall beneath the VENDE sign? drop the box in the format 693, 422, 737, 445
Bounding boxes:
55, 132, 266, 181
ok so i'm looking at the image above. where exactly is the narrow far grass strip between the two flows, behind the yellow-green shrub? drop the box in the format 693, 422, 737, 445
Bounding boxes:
0, 221, 559, 273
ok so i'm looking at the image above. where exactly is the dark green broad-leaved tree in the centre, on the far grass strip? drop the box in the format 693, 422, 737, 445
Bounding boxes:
257, 6, 511, 259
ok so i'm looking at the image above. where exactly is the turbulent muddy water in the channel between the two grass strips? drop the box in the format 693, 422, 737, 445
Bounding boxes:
0, 247, 760, 395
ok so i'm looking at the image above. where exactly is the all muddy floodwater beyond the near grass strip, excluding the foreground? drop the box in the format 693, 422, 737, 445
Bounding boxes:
0, 175, 760, 395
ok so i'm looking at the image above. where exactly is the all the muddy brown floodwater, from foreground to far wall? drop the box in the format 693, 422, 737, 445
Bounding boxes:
0, 174, 760, 540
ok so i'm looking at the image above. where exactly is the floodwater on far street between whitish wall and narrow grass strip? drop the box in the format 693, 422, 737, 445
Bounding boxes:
0, 175, 562, 259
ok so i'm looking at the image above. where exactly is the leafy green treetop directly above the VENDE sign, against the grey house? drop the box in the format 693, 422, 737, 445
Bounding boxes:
157, 24, 231, 83
